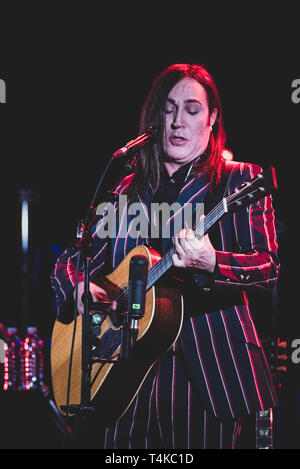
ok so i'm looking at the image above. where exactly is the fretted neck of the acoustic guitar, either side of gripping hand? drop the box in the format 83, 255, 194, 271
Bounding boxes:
147, 198, 227, 290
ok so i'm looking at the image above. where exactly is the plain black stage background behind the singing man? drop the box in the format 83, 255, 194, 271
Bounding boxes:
0, 3, 300, 447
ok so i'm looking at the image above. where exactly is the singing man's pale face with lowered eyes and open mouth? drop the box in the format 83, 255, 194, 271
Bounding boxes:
163, 78, 217, 165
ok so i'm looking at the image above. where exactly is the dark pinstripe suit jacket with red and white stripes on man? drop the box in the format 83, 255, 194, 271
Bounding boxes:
52, 162, 279, 419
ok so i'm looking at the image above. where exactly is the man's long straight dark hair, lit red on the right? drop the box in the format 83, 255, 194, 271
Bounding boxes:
128, 64, 225, 197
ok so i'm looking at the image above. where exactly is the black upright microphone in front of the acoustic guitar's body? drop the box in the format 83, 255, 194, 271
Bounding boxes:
120, 256, 148, 358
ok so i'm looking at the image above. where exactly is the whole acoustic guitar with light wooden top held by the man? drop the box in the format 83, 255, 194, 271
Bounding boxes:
51, 167, 277, 425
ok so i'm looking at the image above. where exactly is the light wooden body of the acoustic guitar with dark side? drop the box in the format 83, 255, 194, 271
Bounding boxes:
51, 246, 183, 426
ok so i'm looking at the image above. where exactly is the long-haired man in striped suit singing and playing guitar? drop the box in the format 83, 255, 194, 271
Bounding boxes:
52, 64, 279, 448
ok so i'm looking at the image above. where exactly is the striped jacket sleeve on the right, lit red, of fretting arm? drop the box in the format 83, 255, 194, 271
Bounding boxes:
195, 163, 280, 289
